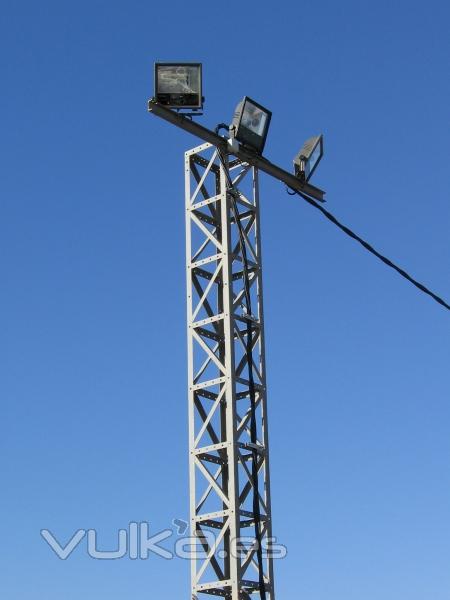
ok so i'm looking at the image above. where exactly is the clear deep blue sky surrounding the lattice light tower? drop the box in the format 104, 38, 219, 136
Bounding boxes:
0, 0, 450, 600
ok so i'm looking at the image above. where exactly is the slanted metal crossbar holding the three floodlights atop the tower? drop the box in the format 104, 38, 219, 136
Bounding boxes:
148, 99, 325, 202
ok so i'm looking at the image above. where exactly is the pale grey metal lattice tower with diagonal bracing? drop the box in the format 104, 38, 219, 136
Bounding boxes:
185, 143, 275, 600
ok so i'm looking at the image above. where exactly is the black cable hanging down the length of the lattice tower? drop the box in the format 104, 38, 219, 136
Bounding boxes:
217, 149, 266, 600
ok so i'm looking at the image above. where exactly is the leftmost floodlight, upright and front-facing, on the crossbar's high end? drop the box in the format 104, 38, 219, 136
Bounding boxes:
155, 63, 203, 110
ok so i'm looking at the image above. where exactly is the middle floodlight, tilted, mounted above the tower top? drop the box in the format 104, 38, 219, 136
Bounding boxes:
231, 96, 272, 154
